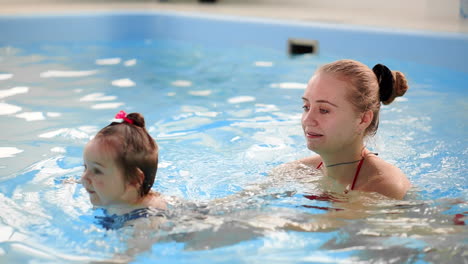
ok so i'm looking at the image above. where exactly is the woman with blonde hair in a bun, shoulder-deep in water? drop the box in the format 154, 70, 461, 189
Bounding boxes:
298, 60, 410, 199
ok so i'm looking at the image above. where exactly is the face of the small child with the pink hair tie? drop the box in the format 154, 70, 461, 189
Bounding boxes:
82, 139, 129, 206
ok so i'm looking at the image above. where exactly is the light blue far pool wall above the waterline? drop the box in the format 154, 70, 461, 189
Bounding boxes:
0, 11, 468, 72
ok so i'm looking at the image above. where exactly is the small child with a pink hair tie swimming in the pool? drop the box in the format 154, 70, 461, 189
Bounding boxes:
82, 111, 166, 229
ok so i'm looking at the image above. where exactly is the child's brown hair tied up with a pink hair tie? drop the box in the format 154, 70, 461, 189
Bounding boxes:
95, 113, 158, 197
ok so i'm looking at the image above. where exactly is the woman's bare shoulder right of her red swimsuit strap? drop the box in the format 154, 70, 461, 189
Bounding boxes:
360, 155, 411, 199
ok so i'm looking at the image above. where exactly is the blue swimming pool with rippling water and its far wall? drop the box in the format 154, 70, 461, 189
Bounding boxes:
0, 12, 468, 263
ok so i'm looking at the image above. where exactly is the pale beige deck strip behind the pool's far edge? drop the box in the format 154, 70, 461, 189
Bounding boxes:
0, 0, 468, 34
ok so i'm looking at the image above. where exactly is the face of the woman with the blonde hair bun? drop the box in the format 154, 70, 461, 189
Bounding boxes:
302, 73, 362, 154
